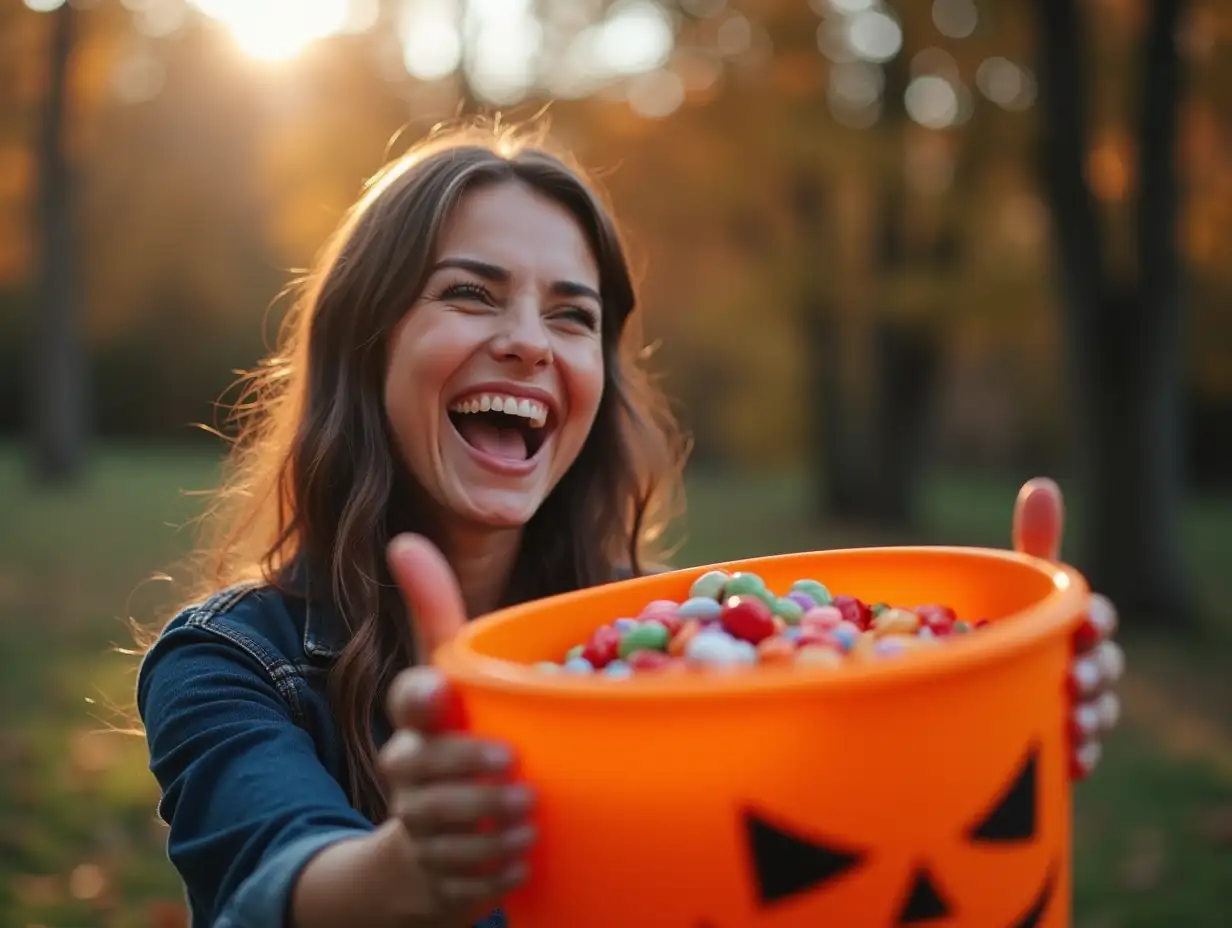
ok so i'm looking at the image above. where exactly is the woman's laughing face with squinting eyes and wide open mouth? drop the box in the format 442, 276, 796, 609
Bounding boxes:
384, 182, 604, 527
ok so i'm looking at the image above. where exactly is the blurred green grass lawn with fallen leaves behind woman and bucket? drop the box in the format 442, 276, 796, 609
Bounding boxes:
0, 450, 1232, 928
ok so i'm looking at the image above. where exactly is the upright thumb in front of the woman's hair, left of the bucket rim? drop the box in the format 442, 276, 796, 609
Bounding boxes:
387, 535, 467, 663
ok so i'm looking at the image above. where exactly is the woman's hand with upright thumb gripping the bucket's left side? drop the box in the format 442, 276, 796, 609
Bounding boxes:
381, 535, 535, 926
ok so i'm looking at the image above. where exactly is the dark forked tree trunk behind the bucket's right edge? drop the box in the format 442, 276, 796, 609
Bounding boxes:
1037, 0, 1190, 624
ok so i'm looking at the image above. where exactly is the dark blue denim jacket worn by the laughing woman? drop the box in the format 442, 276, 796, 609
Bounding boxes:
137, 584, 505, 928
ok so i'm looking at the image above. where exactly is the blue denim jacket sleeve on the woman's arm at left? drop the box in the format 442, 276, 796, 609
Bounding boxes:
137, 624, 373, 928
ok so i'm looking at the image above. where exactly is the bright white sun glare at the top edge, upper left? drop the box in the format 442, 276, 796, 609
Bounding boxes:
193, 0, 349, 62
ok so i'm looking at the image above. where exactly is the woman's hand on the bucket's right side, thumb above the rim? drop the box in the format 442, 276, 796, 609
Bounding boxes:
1014, 478, 1125, 780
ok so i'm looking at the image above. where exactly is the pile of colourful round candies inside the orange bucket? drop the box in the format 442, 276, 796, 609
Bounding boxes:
536, 571, 987, 678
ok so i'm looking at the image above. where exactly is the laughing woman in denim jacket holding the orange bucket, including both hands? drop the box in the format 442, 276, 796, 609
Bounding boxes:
138, 125, 1120, 928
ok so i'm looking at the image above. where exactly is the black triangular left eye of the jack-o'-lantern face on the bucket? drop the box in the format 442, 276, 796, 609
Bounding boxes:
743, 810, 864, 906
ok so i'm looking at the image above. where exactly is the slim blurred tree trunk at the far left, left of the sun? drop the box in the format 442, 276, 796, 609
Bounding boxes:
30, 4, 86, 482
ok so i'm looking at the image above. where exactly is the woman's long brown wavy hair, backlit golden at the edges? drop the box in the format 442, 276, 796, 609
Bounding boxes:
179, 124, 686, 821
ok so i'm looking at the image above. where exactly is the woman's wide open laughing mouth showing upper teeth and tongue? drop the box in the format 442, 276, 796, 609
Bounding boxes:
447, 392, 556, 470
